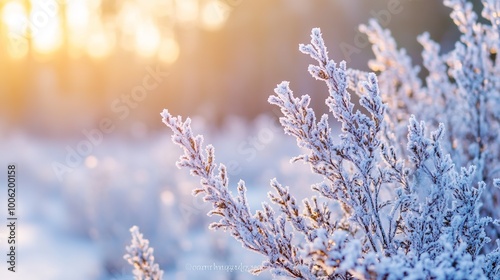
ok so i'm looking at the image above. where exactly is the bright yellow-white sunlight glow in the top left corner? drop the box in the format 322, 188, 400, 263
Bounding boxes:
0, 0, 231, 61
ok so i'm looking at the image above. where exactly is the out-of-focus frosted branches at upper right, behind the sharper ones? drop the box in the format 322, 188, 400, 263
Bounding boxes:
361, 0, 500, 242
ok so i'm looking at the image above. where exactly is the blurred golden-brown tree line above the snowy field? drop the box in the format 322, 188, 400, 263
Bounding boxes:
0, 0, 468, 137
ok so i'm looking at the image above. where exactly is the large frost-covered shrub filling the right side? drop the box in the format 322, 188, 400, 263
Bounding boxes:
162, 0, 500, 279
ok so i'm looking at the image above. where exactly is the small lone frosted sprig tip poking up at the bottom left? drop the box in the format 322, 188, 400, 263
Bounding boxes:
123, 226, 163, 280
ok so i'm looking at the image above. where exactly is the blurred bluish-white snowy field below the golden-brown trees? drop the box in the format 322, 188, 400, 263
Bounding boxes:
0, 117, 320, 280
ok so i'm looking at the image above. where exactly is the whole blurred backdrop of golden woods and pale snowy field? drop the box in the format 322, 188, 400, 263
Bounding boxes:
0, 0, 466, 280
